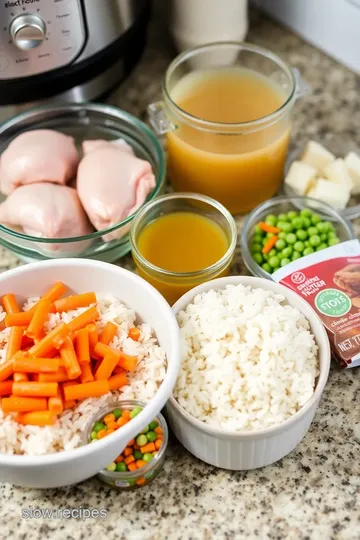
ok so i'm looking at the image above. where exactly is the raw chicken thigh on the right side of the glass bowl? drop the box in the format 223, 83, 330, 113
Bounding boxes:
77, 143, 155, 241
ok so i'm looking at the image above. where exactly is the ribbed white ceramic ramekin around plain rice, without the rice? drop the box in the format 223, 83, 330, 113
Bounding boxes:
167, 276, 331, 471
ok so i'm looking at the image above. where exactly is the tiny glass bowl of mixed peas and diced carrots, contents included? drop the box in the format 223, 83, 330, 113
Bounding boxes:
85, 400, 168, 490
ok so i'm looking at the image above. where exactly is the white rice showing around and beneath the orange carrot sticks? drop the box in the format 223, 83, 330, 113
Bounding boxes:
0, 296, 166, 455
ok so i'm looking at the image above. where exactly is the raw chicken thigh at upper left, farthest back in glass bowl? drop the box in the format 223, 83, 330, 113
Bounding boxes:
0, 129, 79, 195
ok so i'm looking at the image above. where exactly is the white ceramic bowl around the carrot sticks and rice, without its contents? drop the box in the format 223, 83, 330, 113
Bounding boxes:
0, 259, 180, 488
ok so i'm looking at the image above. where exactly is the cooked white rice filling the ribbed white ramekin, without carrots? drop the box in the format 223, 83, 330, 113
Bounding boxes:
174, 285, 319, 432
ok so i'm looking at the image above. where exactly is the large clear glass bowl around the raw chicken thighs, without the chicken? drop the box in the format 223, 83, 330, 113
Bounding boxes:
0, 103, 165, 262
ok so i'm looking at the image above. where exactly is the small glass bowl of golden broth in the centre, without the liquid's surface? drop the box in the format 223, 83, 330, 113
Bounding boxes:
130, 193, 237, 305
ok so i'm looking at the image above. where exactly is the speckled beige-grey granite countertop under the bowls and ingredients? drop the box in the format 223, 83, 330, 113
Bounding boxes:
0, 5, 360, 540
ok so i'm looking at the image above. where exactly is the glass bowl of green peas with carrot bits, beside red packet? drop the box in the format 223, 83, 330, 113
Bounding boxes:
240, 197, 355, 279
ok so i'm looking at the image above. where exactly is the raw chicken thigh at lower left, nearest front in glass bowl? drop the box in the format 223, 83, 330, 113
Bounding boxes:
0, 183, 93, 240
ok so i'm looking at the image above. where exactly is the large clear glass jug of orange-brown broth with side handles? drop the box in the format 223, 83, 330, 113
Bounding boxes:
148, 42, 309, 214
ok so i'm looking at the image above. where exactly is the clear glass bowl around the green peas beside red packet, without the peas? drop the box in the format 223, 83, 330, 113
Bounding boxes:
240, 197, 355, 279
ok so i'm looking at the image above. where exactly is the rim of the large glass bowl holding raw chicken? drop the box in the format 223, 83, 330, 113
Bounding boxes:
0, 102, 165, 244
